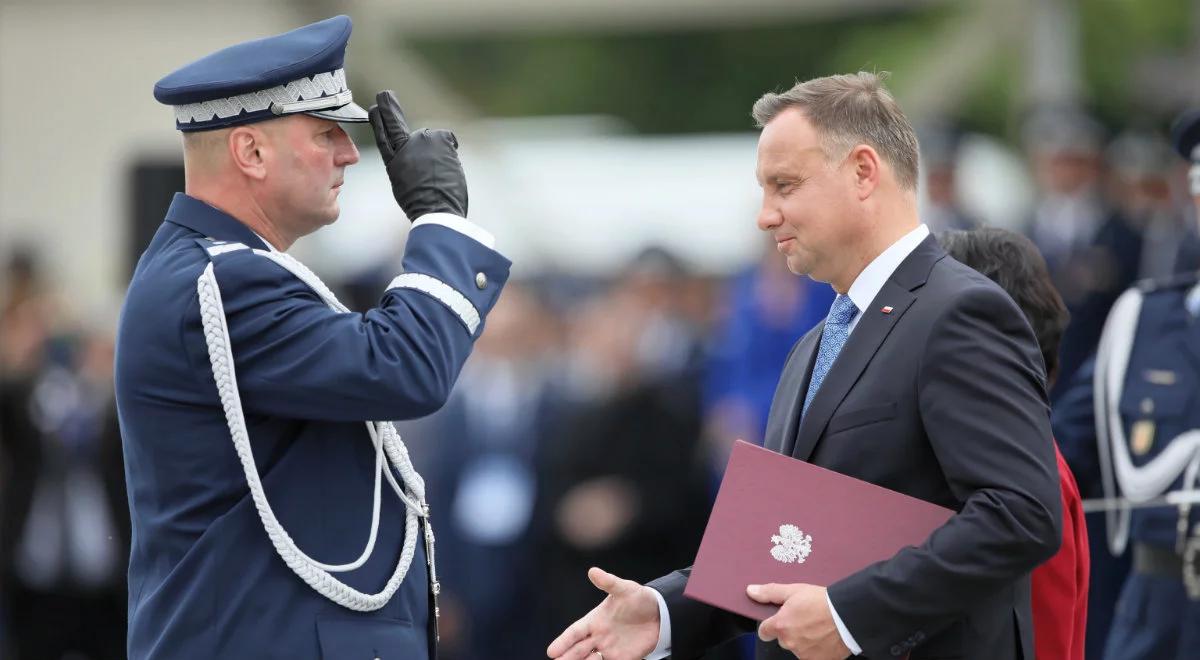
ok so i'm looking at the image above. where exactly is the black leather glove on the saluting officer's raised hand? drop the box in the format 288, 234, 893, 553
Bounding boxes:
367, 90, 467, 220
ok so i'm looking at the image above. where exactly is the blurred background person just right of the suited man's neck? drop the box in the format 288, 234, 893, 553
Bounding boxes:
919, 121, 979, 234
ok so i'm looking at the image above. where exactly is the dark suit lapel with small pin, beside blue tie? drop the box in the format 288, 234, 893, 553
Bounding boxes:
791, 236, 946, 461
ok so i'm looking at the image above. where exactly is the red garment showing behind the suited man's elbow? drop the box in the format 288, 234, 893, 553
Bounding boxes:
1033, 444, 1088, 660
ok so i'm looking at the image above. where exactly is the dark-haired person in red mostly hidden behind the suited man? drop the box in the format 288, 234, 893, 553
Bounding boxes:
937, 227, 1091, 660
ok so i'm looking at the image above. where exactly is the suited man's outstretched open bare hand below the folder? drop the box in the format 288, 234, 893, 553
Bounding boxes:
546, 568, 659, 660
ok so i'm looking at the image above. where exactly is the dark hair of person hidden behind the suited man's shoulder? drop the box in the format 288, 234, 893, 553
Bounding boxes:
937, 227, 1070, 388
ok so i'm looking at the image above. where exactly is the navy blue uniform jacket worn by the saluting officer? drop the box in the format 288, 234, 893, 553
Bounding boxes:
116, 194, 510, 660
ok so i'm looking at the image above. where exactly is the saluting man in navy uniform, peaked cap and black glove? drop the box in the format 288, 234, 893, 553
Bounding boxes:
116, 16, 510, 660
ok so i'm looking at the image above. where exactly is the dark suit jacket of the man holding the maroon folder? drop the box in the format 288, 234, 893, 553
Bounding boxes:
650, 238, 1062, 660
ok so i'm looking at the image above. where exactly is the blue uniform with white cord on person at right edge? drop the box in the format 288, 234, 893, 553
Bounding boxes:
1054, 274, 1200, 660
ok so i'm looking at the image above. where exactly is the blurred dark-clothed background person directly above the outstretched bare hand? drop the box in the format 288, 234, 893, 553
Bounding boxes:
539, 248, 738, 658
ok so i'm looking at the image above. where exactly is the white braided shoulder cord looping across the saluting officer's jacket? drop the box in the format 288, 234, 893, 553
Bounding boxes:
197, 250, 440, 612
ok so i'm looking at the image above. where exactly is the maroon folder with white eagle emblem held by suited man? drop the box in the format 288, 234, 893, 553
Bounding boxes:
684, 440, 954, 620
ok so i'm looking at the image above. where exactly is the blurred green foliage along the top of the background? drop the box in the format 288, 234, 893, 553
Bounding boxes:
407, 0, 1195, 134
